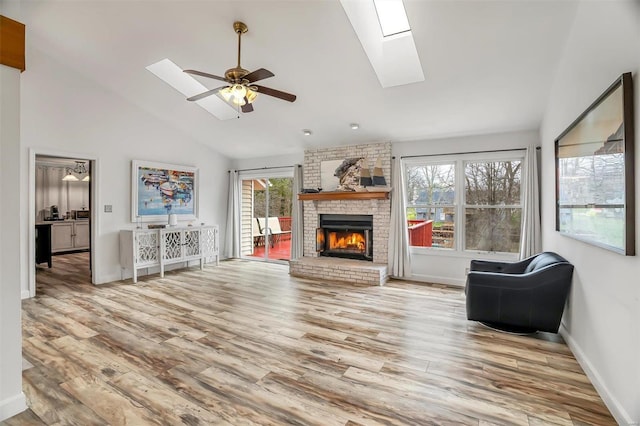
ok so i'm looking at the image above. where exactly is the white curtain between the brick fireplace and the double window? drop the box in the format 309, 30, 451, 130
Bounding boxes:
389, 157, 411, 278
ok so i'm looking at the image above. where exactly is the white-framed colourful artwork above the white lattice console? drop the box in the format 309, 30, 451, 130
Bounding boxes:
131, 160, 199, 222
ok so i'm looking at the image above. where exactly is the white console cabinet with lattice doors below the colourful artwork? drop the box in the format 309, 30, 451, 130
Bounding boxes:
120, 225, 219, 283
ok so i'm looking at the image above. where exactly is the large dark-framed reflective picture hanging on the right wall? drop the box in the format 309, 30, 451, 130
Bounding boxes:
555, 73, 635, 256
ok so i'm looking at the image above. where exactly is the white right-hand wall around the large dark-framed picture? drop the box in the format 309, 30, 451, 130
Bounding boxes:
541, 1, 640, 425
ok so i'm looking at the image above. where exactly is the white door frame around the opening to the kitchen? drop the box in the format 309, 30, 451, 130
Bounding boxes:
22, 148, 100, 299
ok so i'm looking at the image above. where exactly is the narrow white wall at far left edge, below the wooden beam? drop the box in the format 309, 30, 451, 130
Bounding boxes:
0, 65, 26, 421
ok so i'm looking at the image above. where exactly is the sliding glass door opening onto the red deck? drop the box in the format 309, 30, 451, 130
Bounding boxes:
240, 168, 293, 261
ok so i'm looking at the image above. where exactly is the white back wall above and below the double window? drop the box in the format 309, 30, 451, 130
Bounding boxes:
391, 131, 539, 286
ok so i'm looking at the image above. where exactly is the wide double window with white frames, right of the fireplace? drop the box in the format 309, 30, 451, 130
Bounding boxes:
405, 152, 524, 253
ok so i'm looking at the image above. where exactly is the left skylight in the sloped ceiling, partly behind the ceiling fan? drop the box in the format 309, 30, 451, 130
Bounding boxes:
146, 59, 238, 120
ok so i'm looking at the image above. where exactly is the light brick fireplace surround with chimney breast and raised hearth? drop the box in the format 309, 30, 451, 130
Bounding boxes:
289, 143, 391, 285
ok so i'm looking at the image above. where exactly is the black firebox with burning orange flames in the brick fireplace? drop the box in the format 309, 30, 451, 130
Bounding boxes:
316, 214, 373, 261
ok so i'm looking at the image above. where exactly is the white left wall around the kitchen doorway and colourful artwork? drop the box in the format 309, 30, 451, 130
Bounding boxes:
21, 38, 230, 289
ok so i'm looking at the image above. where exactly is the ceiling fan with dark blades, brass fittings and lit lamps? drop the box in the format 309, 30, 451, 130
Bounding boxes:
184, 22, 296, 112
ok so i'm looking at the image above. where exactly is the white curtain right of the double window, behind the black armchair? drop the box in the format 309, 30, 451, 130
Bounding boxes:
520, 145, 542, 259
